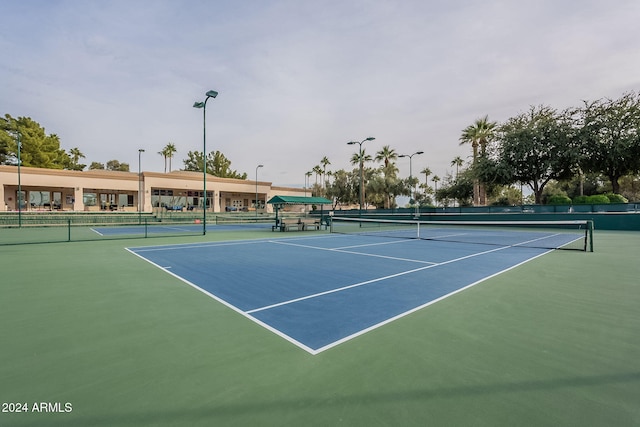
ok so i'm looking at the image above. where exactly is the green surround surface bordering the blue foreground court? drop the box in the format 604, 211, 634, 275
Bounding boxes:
0, 230, 640, 426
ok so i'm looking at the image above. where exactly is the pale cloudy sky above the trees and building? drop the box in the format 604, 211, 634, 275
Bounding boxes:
0, 0, 640, 187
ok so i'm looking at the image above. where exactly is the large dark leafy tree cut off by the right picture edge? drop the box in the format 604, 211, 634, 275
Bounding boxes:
578, 93, 640, 194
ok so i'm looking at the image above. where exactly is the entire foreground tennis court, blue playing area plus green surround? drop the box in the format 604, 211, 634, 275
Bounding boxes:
0, 219, 640, 427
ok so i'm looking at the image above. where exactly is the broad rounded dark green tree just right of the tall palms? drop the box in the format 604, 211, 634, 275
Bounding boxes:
474, 106, 579, 207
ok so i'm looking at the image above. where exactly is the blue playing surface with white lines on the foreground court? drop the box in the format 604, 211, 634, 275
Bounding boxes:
128, 234, 568, 354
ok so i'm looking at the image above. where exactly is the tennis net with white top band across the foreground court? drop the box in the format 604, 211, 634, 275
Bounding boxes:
331, 217, 593, 252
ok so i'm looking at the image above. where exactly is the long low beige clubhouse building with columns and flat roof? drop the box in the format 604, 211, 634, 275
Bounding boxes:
0, 165, 305, 212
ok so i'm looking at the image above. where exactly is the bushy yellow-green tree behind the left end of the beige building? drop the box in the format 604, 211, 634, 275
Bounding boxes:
0, 114, 70, 169
